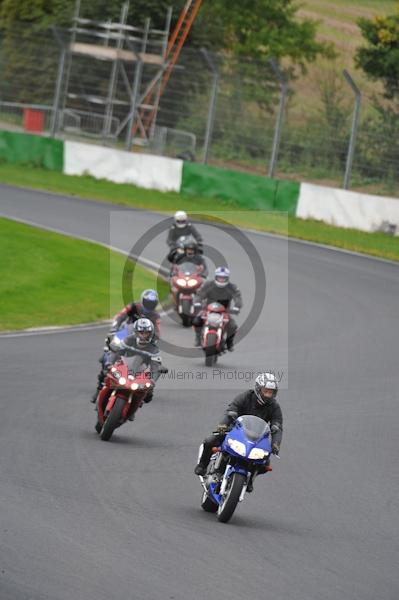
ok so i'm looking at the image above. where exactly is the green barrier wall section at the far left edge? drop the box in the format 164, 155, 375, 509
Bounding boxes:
0, 131, 64, 171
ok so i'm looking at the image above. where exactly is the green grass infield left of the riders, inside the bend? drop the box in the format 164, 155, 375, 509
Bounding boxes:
0, 218, 169, 331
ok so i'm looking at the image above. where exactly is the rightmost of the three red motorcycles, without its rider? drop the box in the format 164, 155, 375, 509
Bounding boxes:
201, 302, 237, 367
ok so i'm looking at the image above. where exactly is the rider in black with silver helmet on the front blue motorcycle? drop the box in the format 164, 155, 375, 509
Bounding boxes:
194, 372, 283, 492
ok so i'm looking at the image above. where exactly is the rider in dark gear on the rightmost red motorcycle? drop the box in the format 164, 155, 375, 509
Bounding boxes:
193, 267, 242, 352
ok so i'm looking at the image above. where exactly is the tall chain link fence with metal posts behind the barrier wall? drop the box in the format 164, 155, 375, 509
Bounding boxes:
0, 24, 399, 195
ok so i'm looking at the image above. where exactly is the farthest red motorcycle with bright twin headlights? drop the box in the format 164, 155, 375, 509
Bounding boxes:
170, 262, 204, 327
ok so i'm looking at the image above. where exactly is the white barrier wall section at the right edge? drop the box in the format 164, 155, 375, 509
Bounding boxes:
296, 183, 399, 233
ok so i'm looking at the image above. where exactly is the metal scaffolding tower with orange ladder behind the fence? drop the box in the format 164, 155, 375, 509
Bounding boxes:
52, 0, 202, 149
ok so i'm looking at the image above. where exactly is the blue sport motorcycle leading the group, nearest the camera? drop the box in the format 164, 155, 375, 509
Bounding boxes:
199, 415, 272, 523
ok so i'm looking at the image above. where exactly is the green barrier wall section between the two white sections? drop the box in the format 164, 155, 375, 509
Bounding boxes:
180, 162, 300, 215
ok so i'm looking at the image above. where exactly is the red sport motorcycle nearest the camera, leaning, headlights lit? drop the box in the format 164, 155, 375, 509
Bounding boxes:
95, 350, 155, 441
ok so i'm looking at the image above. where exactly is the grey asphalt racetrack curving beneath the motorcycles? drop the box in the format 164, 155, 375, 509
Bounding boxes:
0, 186, 399, 600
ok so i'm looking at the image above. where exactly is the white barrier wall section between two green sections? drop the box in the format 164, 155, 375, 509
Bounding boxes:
64, 141, 183, 192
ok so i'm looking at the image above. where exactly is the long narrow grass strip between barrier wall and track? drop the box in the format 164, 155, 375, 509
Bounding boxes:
0, 163, 399, 261
